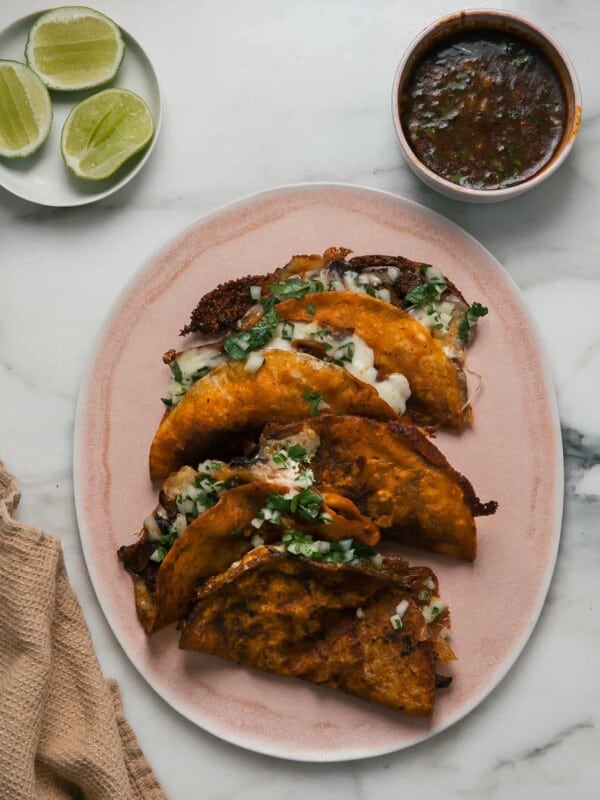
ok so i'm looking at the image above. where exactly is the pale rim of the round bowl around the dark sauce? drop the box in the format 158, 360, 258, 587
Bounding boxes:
392, 8, 582, 202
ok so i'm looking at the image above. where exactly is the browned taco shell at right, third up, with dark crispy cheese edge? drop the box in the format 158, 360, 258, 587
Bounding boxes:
262, 415, 497, 561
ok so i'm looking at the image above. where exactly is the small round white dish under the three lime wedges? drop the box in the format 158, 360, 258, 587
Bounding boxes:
0, 10, 162, 207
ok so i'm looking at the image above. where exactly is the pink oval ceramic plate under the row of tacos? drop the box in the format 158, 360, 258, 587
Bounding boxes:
74, 184, 563, 761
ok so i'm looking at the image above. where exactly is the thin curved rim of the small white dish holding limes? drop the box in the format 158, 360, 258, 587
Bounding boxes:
0, 6, 163, 208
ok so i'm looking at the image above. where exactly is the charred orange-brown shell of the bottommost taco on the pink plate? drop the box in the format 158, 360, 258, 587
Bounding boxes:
180, 547, 453, 717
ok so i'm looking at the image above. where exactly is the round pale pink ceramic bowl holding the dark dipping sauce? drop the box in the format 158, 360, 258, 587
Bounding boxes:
392, 9, 581, 203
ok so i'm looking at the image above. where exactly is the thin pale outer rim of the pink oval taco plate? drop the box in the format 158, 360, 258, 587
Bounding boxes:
73, 181, 564, 763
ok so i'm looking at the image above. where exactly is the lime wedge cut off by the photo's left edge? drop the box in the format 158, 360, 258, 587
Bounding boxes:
0, 61, 52, 158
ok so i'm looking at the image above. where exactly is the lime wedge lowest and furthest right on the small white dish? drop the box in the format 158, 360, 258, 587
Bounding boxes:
60, 89, 154, 181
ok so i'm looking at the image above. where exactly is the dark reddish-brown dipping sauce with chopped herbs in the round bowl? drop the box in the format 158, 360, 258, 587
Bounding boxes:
399, 30, 567, 189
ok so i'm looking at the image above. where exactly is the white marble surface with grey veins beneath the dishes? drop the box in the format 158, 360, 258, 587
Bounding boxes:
0, 0, 600, 800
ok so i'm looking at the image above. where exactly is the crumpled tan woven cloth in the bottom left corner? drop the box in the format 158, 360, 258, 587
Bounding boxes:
0, 461, 166, 800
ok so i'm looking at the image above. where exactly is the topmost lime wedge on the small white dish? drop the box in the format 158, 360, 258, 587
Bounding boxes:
25, 6, 125, 92
